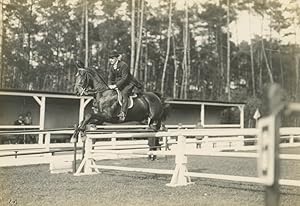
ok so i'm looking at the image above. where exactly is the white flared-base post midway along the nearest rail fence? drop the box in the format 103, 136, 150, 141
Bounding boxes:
167, 136, 192, 187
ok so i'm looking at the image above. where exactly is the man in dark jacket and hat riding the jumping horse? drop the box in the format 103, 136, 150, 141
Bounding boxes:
108, 50, 142, 121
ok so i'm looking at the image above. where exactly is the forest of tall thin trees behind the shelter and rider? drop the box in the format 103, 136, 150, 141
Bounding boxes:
0, 0, 300, 126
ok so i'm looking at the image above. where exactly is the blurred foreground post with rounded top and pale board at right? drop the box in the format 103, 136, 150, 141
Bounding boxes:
259, 84, 285, 206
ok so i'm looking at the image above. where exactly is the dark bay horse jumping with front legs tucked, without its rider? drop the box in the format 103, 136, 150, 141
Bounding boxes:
71, 68, 168, 142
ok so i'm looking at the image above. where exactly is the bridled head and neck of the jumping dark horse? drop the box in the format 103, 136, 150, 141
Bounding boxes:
74, 62, 107, 96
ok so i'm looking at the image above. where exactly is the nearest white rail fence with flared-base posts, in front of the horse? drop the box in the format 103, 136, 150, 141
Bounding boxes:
75, 126, 300, 187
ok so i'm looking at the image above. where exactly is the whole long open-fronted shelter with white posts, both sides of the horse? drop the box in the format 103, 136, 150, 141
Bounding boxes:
0, 89, 245, 143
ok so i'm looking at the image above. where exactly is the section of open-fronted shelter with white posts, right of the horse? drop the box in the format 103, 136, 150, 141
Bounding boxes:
166, 99, 245, 128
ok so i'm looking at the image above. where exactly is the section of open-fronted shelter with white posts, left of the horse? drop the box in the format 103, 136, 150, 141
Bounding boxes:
0, 89, 92, 142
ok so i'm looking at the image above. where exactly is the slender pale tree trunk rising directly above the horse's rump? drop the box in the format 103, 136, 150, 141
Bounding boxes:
160, 0, 172, 95
